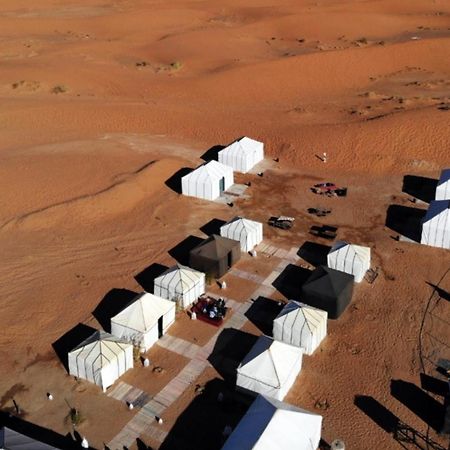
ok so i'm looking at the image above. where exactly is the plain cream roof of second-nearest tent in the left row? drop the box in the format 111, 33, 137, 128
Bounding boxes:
111, 292, 175, 333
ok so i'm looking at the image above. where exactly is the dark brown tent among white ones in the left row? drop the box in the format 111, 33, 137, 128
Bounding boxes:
189, 234, 241, 278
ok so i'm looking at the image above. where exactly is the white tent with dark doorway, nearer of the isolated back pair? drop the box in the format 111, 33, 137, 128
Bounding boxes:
181, 161, 234, 200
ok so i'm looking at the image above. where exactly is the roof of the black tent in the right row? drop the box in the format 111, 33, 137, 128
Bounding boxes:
303, 266, 355, 297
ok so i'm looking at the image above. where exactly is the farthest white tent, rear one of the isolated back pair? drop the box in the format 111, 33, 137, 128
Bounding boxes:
219, 137, 264, 173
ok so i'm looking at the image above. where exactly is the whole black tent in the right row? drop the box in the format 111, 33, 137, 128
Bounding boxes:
301, 266, 355, 319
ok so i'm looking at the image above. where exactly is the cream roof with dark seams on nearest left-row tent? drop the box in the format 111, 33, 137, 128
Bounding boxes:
69, 331, 132, 368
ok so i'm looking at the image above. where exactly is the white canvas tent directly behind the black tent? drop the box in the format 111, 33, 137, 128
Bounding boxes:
327, 241, 370, 283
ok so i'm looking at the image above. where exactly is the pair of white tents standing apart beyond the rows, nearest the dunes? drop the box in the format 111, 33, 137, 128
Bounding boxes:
181, 137, 264, 200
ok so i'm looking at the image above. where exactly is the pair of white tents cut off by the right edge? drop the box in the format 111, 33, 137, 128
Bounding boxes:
420, 169, 450, 249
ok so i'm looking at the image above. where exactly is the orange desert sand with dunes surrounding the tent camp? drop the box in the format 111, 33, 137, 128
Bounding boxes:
0, 0, 450, 450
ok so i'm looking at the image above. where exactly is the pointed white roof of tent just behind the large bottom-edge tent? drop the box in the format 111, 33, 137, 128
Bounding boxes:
238, 336, 303, 388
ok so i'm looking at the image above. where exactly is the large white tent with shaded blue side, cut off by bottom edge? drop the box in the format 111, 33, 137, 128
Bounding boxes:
222, 395, 322, 450
